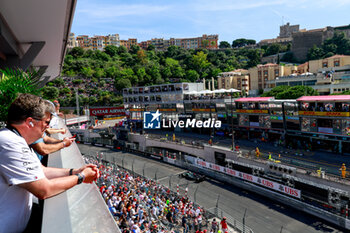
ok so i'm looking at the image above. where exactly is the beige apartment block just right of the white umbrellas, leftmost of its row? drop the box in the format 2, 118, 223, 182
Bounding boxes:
217, 69, 250, 93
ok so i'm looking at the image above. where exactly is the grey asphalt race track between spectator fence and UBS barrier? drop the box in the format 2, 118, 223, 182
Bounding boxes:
78, 144, 345, 233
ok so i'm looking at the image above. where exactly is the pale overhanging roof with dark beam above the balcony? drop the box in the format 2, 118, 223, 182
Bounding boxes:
0, 0, 77, 84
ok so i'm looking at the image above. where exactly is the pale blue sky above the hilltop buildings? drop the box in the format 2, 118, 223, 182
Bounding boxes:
71, 0, 350, 43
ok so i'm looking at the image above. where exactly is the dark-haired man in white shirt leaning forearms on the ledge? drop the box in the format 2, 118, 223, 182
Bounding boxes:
0, 94, 99, 232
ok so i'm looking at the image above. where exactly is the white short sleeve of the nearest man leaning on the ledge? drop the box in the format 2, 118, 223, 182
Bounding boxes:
0, 138, 45, 185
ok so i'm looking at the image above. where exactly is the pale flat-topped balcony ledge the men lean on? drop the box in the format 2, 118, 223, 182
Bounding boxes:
42, 121, 120, 233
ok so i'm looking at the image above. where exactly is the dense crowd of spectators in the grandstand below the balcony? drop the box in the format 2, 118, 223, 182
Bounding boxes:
85, 158, 223, 233
